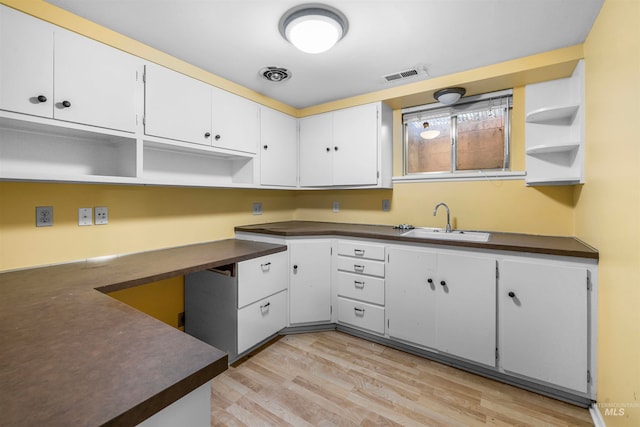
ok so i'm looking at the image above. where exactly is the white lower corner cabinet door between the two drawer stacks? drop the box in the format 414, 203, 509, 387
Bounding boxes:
287, 239, 331, 325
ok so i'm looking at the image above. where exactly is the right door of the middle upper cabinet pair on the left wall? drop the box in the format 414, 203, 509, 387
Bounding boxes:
211, 87, 260, 154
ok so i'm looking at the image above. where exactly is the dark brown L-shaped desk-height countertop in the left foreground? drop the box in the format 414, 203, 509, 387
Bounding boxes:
0, 239, 286, 426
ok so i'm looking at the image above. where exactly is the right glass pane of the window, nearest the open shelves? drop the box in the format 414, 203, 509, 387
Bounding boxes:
456, 108, 505, 170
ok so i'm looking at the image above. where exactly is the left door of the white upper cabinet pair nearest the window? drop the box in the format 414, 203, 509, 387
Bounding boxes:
300, 113, 334, 187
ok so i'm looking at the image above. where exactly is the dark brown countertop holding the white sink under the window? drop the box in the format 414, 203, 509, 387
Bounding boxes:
235, 221, 599, 260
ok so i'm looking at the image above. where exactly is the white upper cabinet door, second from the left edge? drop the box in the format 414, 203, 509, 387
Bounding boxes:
54, 29, 139, 132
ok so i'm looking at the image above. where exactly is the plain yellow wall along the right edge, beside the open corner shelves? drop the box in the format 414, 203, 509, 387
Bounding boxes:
575, 0, 640, 426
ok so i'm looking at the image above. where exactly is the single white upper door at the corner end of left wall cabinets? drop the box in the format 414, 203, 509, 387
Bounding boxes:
260, 107, 298, 187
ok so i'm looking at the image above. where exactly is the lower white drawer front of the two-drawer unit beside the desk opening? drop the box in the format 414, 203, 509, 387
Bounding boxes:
238, 291, 287, 354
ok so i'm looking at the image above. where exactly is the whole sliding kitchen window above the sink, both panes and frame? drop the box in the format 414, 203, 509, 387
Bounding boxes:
402, 90, 512, 180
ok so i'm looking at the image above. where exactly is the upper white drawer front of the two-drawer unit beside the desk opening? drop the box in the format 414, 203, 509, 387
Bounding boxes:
238, 252, 289, 308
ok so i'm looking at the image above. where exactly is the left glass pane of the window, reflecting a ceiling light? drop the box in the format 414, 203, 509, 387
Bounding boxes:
406, 116, 451, 174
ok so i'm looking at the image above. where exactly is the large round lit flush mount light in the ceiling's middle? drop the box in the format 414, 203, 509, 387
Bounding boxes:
278, 3, 349, 53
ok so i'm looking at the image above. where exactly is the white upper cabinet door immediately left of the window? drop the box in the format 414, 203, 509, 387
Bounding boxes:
332, 104, 380, 185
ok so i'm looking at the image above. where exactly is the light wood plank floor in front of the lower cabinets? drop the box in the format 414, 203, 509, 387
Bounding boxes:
211, 332, 593, 426
